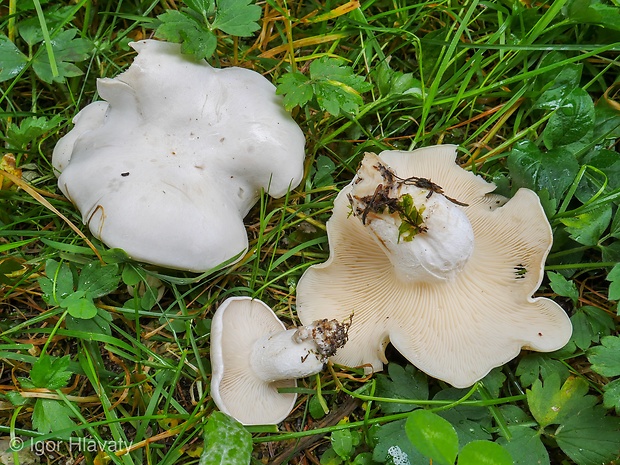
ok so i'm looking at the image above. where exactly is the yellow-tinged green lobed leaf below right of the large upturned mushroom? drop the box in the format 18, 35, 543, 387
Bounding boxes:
526, 374, 596, 428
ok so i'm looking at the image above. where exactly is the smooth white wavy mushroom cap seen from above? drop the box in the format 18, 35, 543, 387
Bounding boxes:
52, 40, 305, 271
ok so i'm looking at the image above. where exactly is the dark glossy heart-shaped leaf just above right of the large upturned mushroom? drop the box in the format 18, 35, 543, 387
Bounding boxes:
507, 141, 579, 199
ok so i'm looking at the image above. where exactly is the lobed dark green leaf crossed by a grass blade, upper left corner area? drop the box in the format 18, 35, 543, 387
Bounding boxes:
32, 29, 92, 84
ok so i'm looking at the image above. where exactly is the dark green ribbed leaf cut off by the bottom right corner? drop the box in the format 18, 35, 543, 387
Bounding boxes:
554, 405, 620, 465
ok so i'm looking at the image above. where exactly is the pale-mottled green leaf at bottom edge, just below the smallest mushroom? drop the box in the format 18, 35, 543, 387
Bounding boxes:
198, 412, 252, 465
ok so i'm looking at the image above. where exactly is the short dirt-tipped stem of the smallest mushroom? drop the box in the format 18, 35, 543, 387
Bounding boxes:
250, 320, 350, 382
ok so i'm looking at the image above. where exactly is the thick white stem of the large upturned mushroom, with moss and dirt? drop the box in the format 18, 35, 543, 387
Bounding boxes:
348, 153, 474, 282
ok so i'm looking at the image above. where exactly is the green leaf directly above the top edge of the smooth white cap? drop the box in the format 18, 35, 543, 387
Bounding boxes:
155, 10, 217, 60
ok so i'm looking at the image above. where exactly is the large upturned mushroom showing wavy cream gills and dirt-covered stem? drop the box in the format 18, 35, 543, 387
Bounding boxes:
297, 145, 572, 387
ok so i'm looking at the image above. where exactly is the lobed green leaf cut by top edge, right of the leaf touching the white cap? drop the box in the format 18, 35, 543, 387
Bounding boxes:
213, 0, 262, 37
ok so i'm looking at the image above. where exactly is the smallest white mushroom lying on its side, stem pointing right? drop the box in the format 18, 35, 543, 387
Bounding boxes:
210, 297, 348, 425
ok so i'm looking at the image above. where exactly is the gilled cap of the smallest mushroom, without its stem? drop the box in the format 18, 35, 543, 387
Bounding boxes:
211, 297, 297, 425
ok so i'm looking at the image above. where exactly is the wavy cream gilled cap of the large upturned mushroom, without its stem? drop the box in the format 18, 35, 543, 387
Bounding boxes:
297, 145, 572, 387
